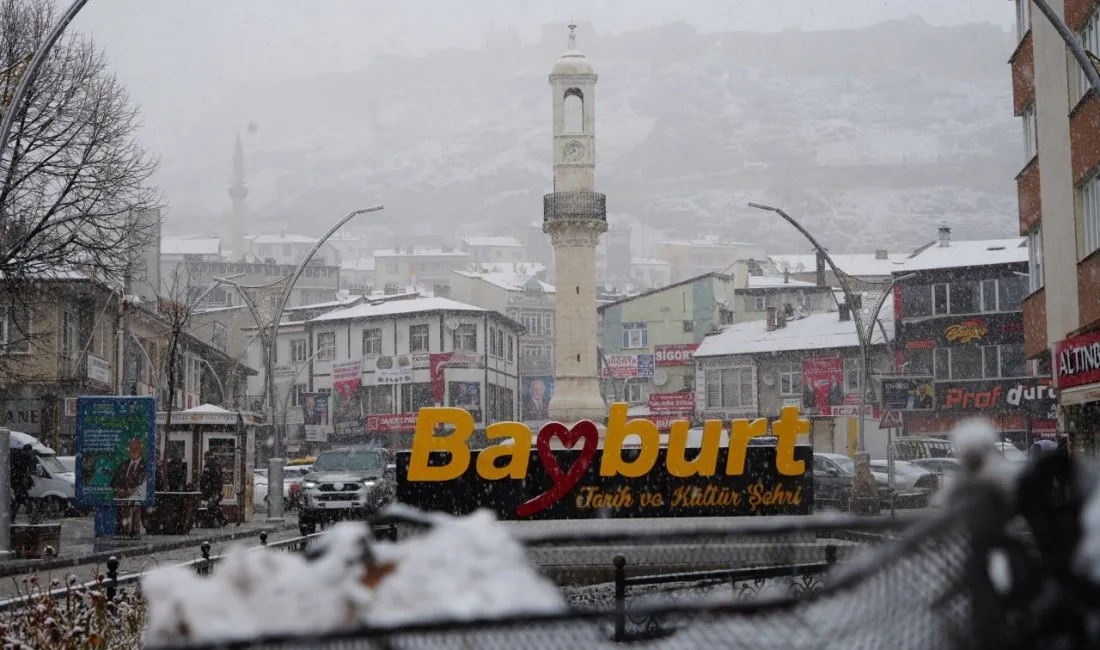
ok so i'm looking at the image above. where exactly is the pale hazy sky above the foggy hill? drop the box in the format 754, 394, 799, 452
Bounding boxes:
75, 0, 1014, 145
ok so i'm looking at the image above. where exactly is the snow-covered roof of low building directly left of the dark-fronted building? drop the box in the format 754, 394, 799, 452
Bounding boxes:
695, 299, 894, 359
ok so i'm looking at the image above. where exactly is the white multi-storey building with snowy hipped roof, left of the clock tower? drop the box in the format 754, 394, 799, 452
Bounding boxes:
304, 297, 521, 449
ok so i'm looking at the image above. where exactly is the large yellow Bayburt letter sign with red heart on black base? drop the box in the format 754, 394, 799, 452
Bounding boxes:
397, 404, 813, 519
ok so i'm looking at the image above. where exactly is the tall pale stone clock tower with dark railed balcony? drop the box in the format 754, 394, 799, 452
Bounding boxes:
542, 24, 607, 423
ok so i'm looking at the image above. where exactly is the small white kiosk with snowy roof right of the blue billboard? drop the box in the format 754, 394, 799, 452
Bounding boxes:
156, 404, 263, 524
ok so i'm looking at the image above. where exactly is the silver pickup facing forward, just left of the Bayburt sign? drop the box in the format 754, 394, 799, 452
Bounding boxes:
298, 447, 395, 535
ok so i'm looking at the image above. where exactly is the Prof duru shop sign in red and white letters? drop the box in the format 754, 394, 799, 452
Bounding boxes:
936, 377, 1058, 419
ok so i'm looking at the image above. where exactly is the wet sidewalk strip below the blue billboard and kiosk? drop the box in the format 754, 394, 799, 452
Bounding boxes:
0, 513, 298, 577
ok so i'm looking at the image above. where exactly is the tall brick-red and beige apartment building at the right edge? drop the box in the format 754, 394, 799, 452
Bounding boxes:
1010, 0, 1100, 456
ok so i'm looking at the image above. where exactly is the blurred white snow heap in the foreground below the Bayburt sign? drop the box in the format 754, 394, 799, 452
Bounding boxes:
142, 510, 565, 645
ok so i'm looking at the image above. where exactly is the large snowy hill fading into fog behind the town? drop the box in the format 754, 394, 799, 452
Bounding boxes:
163, 18, 1023, 252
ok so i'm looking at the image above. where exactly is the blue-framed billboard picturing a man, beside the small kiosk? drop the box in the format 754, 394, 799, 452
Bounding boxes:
76, 397, 156, 506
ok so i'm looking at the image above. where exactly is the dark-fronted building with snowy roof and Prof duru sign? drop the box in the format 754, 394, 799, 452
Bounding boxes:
894, 227, 1056, 448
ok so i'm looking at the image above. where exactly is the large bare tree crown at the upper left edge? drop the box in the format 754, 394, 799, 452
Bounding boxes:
0, 0, 160, 282
